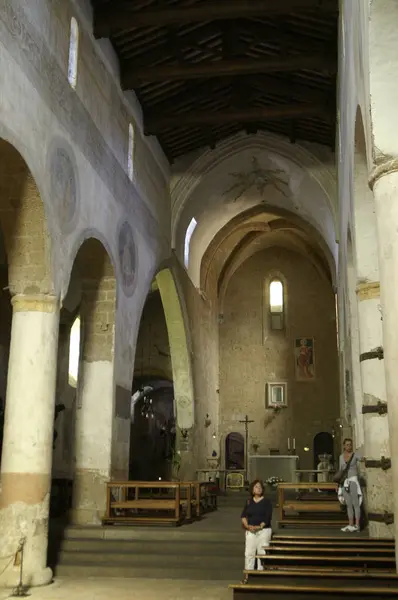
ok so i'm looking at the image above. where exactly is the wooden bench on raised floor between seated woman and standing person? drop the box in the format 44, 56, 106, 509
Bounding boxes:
278, 482, 347, 527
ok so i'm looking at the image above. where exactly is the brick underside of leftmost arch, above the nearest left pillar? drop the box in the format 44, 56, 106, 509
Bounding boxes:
0, 139, 54, 295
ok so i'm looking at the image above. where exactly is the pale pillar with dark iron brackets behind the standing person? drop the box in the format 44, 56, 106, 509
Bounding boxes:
357, 281, 393, 537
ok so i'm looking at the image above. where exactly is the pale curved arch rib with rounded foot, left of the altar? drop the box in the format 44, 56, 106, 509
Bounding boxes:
155, 268, 195, 429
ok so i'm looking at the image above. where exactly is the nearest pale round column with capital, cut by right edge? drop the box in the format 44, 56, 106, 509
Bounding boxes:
370, 159, 398, 537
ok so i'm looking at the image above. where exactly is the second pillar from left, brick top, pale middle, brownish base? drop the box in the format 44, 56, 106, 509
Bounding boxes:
71, 277, 115, 525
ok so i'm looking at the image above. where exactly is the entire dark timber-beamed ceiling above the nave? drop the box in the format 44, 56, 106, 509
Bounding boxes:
91, 0, 338, 161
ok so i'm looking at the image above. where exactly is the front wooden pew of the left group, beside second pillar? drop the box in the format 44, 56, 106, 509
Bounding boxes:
102, 481, 184, 525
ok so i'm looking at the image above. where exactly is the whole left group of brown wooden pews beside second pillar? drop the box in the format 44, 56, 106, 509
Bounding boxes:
102, 481, 217, 525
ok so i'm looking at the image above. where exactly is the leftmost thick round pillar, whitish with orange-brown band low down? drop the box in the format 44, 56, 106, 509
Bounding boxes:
0, 295, 59, 586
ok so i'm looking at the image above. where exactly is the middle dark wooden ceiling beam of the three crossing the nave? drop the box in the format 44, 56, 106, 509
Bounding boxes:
121, 55, 337, 90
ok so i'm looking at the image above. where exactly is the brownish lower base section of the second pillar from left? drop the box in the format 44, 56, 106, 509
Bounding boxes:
70, 469, 110, 525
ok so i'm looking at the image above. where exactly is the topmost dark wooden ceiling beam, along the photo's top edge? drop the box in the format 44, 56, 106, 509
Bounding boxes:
94, 0, 338, 38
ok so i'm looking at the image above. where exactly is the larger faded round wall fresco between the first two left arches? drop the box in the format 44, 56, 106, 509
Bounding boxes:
50, 146, 78, 229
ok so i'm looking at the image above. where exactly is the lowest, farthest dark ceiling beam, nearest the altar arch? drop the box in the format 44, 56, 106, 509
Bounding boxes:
144, 104, 328, 135
